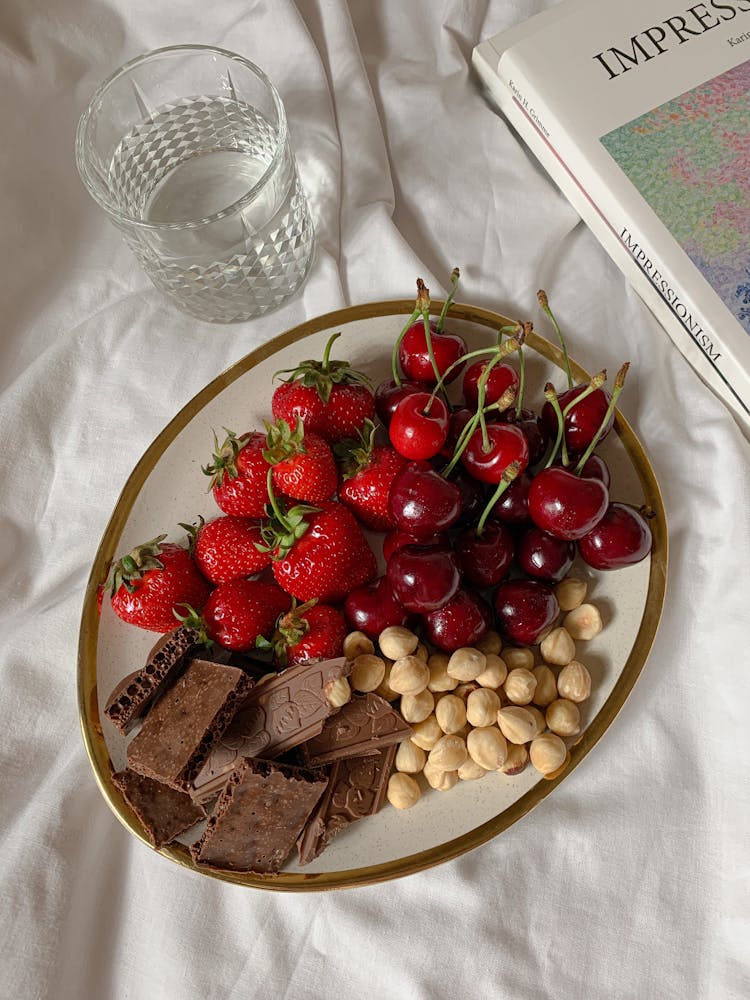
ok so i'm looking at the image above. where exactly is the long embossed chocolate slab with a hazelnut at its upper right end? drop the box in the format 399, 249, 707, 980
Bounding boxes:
193, 656, 351, 802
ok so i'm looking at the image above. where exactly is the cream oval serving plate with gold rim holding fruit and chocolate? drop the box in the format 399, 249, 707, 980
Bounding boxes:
78, 300, 667, 891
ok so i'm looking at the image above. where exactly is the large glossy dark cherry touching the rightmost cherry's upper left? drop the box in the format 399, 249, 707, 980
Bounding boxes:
529, 465, 609, 540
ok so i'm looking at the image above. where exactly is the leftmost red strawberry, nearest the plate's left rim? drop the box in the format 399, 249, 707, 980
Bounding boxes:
105, 535, 210, 632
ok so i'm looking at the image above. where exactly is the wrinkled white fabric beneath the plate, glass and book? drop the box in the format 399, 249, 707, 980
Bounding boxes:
0, 0, 750, 1000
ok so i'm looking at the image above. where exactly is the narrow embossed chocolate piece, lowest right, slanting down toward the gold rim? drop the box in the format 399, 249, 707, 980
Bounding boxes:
297, 743, 398, 865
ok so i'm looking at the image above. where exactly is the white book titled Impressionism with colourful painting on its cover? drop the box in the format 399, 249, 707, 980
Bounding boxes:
473, 0, 750, 435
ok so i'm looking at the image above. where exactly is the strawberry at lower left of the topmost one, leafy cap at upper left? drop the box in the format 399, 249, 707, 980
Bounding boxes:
203, 428, 268, 517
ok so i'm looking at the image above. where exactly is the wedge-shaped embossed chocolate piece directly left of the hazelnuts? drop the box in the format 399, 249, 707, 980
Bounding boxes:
303, 692, 414, 767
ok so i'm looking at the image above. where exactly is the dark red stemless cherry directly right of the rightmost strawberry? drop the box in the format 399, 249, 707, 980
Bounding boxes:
388, 462, 461, 538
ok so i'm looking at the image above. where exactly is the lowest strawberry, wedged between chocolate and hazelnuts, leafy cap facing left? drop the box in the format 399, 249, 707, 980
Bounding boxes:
259, 601, 347, 669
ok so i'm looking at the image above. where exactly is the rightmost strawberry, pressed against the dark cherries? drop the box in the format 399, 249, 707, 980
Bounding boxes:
334, 420, 406, 531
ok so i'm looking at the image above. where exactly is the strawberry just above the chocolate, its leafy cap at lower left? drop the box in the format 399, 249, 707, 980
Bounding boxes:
200, 580, 291, 653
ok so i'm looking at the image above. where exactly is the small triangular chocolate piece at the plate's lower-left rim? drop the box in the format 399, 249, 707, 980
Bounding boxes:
112, 769, 206, 848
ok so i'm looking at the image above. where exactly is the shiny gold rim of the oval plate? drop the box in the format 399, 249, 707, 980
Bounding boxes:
78, 299, 667, 892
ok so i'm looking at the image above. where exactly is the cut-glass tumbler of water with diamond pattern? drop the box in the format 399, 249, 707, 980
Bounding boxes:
76, 45, 314, 323
